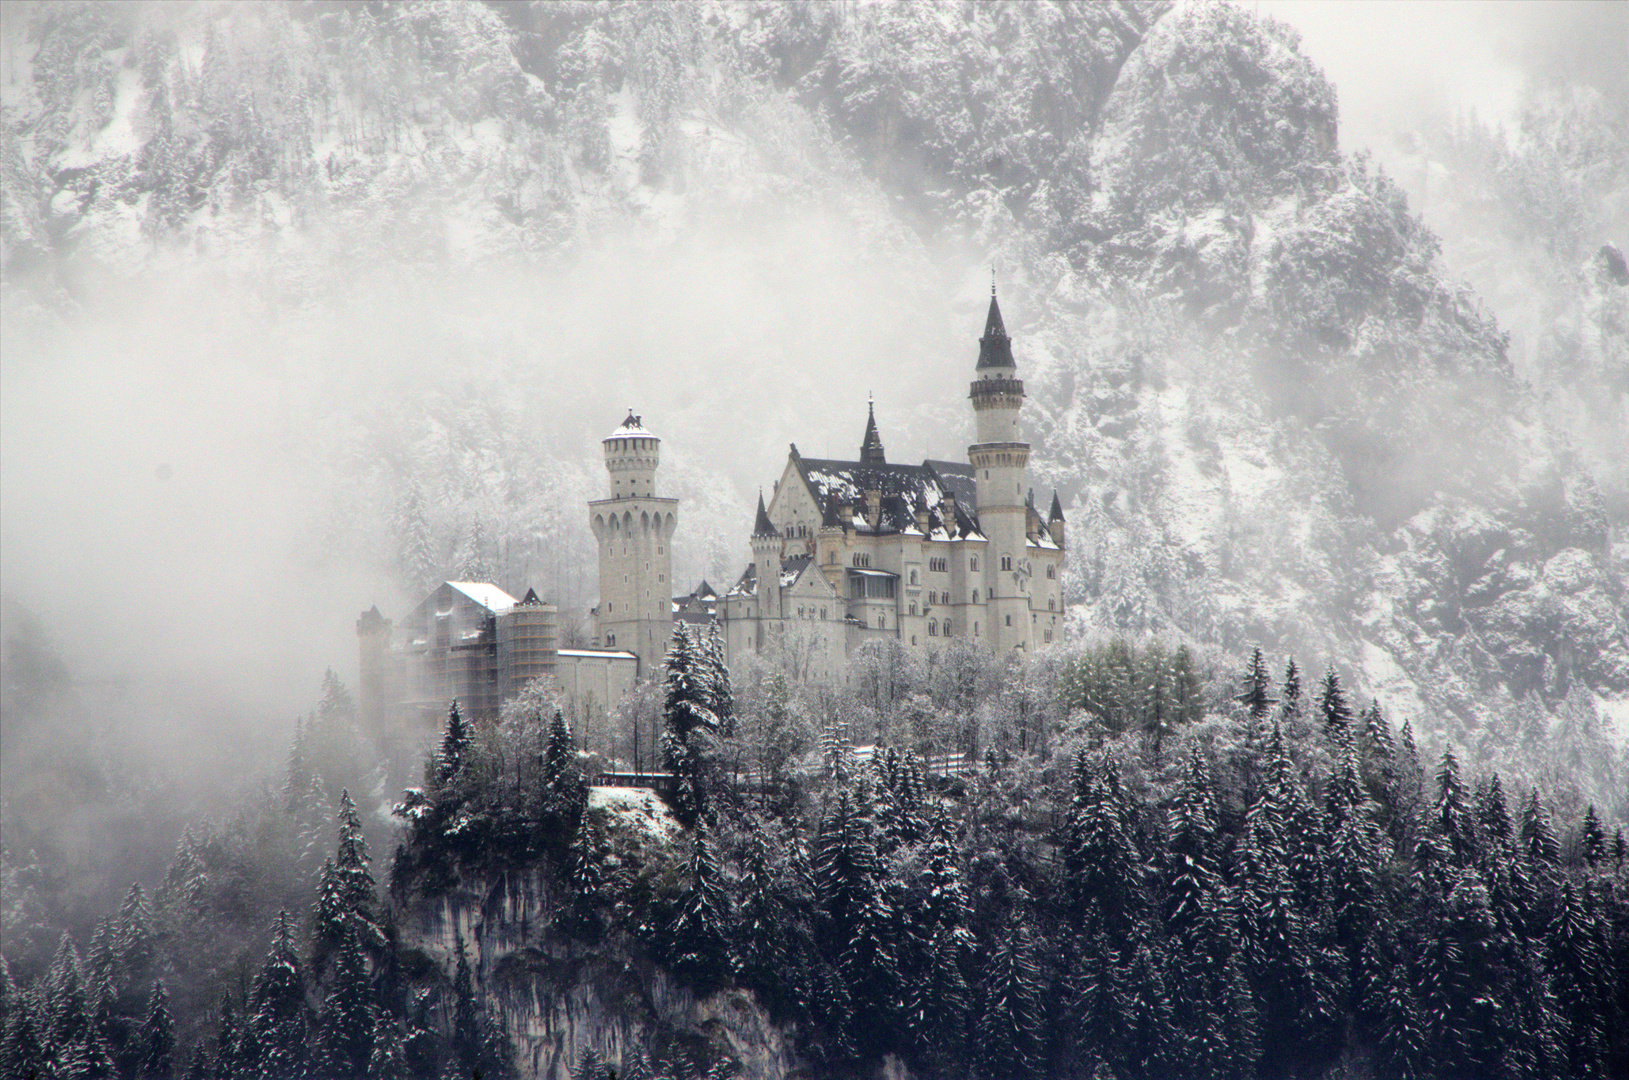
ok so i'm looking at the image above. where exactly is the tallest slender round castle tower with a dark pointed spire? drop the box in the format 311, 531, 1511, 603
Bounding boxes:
968, 283, 1031, 655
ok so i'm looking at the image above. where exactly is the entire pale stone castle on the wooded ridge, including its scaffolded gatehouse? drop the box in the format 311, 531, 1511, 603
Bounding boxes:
357, 287, 1064, 723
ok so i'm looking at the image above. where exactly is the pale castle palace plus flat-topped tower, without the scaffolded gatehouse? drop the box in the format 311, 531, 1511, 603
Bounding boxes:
591, 290, 1064, 673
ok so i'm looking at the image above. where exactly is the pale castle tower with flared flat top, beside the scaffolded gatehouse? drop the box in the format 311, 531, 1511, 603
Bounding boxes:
588, 412, 679, 678
